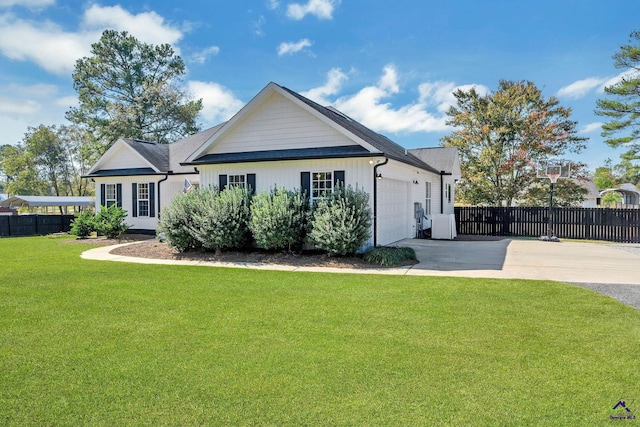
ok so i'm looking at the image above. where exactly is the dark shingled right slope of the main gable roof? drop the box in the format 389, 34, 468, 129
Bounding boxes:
280, 86, 439, 173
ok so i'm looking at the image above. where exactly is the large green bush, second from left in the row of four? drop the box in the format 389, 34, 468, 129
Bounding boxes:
189, 187, 250, 253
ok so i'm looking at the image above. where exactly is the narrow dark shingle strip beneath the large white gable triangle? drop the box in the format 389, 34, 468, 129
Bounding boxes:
190, 145, 371, 165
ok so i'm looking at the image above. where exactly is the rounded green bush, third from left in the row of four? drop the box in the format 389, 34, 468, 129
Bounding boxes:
249, 188, 309, 252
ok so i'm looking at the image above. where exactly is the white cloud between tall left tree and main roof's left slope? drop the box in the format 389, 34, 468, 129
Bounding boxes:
187, 81, 244, 126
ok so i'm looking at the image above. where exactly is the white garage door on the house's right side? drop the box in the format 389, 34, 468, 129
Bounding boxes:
378, 178, 412, 245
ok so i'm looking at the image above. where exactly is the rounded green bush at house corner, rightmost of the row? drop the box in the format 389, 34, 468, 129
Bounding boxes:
309, 186, 371, 256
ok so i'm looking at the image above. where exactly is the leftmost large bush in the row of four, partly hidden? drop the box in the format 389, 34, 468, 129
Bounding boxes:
158, 189, 205, 252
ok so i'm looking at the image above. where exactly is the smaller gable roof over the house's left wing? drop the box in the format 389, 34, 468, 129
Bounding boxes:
86, 123, 224, 177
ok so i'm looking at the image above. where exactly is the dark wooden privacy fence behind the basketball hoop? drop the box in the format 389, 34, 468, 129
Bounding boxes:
455, 206, 640, 243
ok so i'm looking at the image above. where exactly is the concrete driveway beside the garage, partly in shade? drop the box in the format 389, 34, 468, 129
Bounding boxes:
397, 239, 640, 285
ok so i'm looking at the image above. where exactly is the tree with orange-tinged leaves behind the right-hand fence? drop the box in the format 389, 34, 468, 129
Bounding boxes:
442, 81, 586, 206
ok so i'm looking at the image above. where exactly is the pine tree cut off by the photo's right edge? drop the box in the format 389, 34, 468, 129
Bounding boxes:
596, 31, 640, 161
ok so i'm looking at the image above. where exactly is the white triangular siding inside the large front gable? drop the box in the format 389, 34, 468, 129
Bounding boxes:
202, 93, 357, 154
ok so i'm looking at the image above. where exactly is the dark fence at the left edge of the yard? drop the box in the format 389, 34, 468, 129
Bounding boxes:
0, 215, 75, 237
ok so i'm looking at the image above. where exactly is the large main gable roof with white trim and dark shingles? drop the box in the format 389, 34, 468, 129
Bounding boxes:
188, 82, 439, 173
